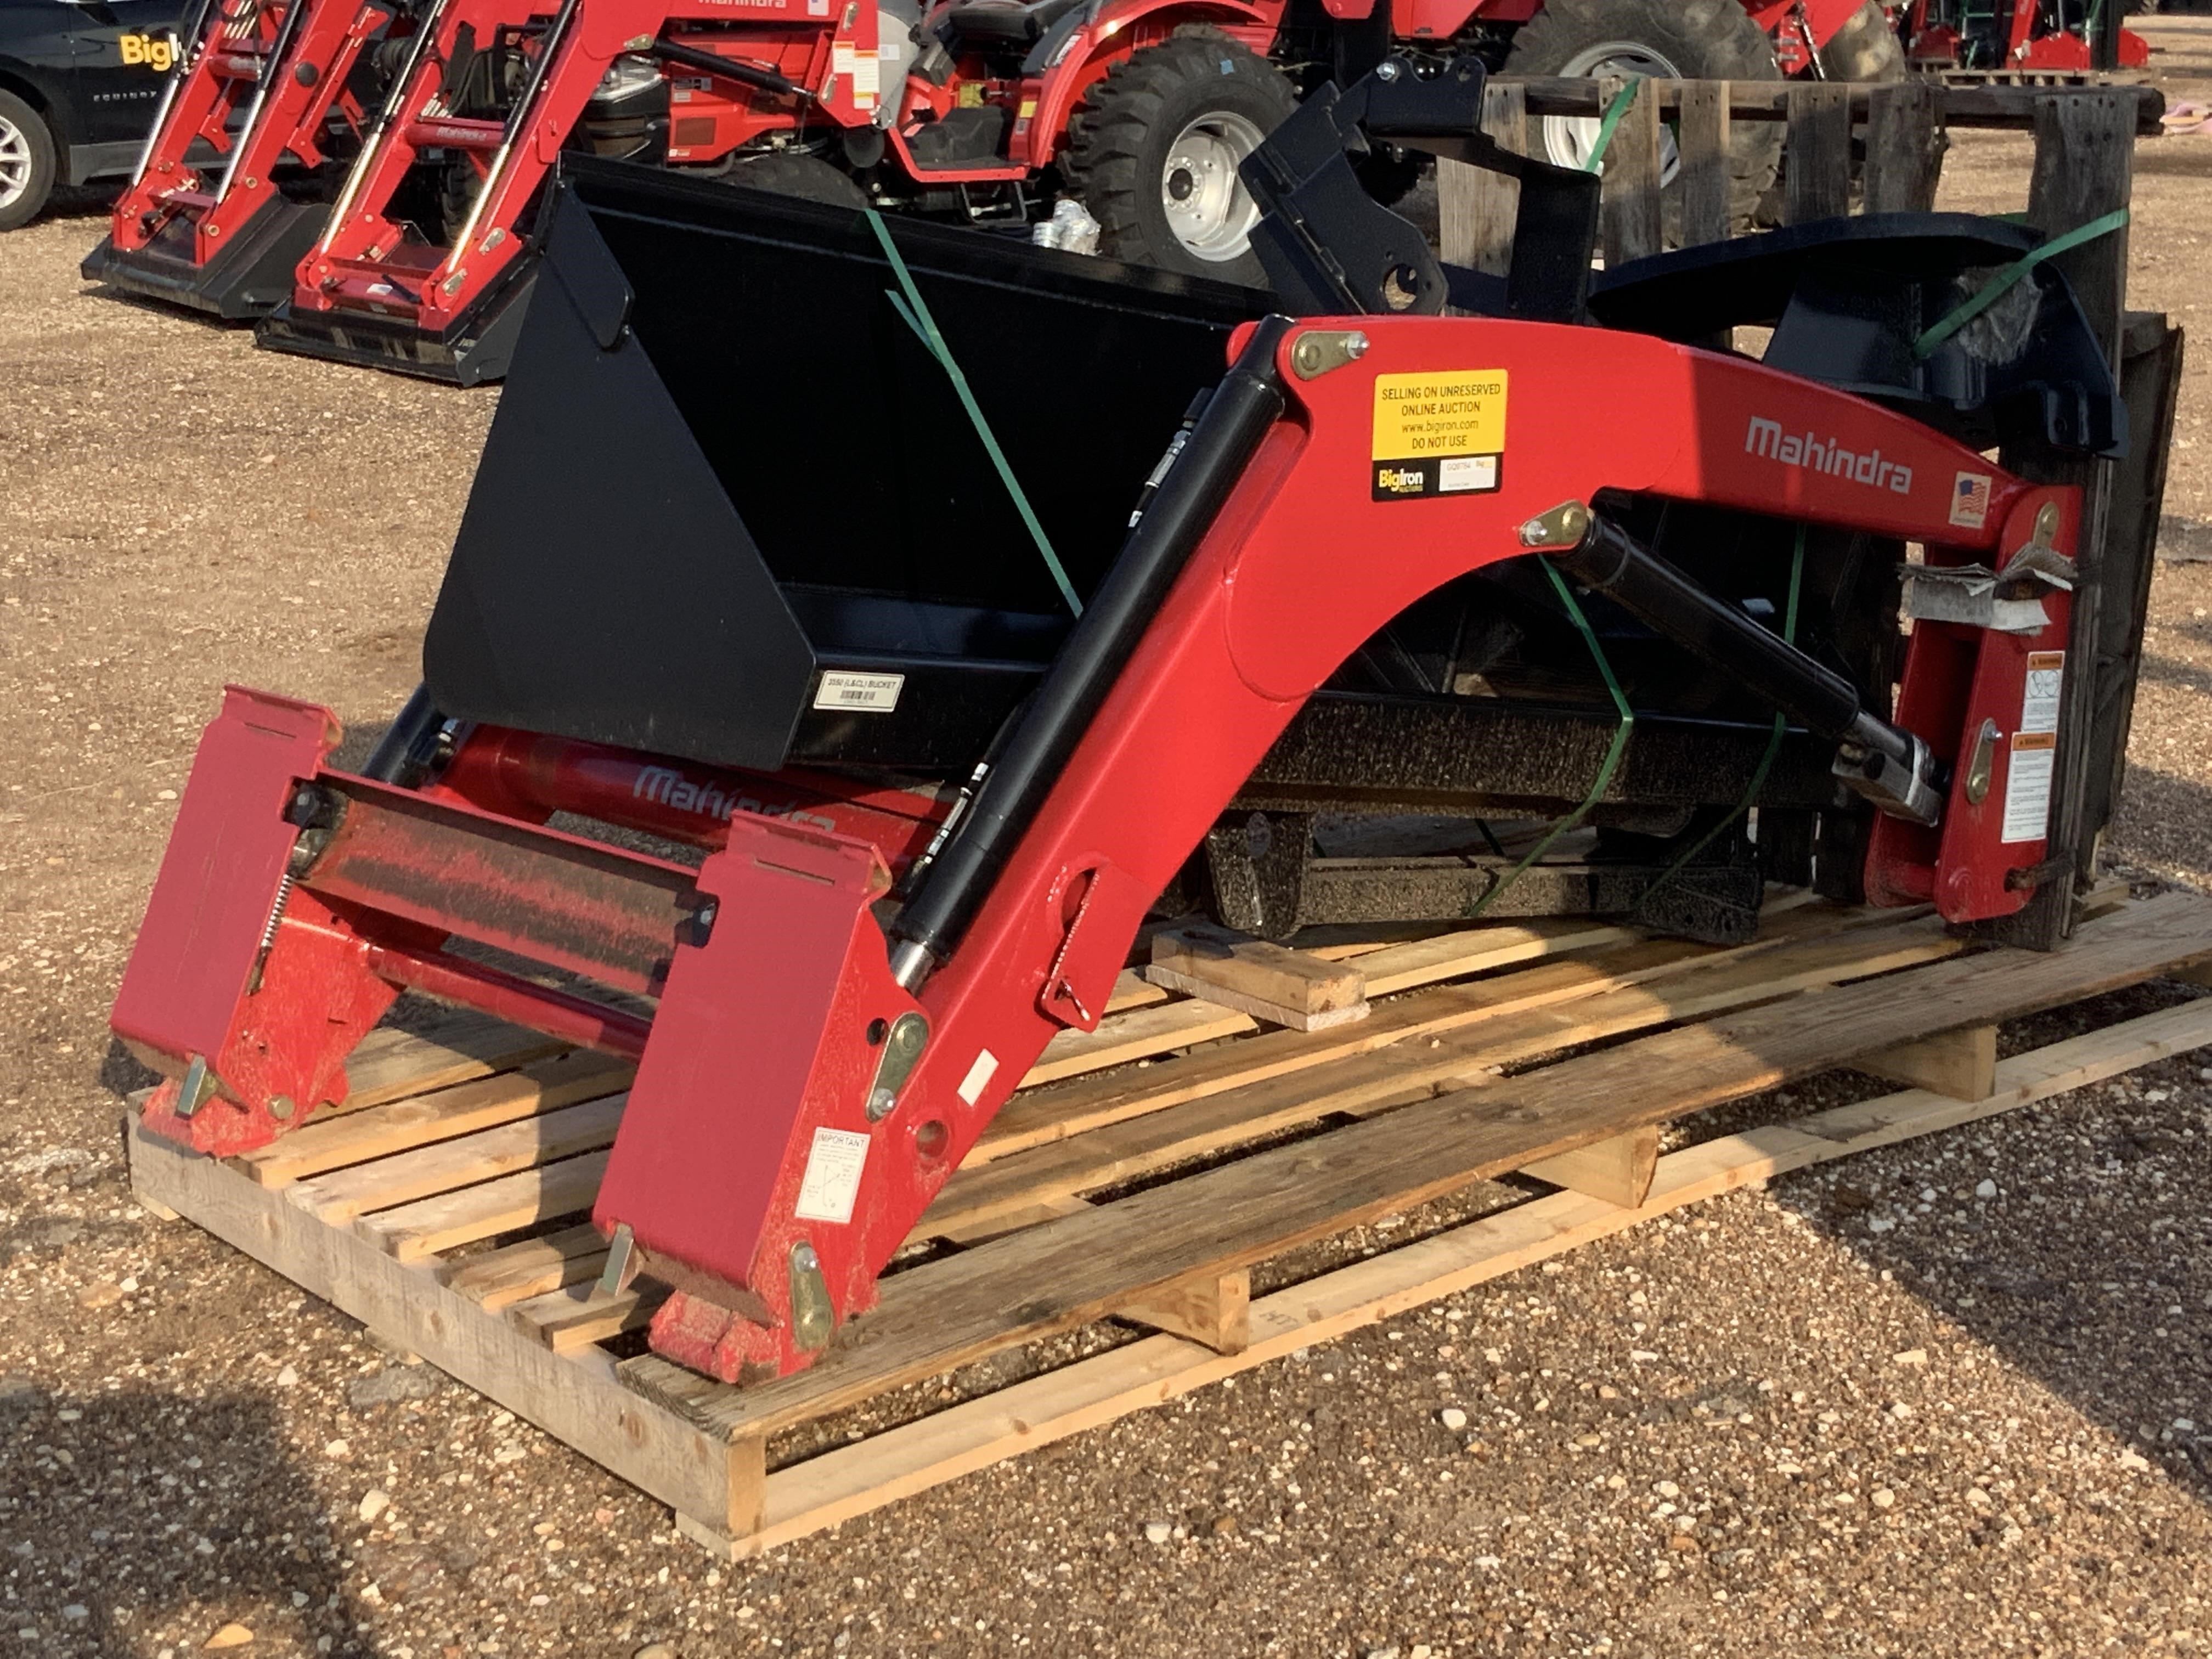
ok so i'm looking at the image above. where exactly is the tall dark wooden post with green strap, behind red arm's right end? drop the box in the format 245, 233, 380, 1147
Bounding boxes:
1980, 88, 2137, 951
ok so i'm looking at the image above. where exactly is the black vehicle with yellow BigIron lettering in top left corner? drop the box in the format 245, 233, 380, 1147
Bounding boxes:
0, 0, 186, 230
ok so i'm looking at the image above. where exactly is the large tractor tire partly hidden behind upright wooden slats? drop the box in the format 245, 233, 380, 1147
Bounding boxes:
1506, 0, 1783, 228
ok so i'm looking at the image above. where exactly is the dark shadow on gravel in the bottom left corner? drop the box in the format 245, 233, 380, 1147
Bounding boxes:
0, 1376, 358, 1659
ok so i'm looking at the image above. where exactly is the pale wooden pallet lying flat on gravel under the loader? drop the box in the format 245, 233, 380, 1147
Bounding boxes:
131, 894, 2212, 1555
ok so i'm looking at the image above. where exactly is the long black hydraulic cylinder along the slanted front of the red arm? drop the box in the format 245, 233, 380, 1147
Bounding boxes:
891, 317, 1292, 973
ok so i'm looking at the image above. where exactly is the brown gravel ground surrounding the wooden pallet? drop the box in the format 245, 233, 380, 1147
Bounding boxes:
0, 29, 2212, 1659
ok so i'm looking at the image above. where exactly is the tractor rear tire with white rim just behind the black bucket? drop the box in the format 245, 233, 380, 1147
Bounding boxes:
1059, 28, 1300, 287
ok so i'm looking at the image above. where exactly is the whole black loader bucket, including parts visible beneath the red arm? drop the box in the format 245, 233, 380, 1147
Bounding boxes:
425, 133, 1990, 938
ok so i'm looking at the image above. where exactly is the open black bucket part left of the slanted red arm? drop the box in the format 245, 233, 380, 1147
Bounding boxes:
425, 161, 1265, 772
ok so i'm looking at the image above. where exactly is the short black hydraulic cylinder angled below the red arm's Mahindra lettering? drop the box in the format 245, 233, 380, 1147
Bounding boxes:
1544, 513, 1860, 741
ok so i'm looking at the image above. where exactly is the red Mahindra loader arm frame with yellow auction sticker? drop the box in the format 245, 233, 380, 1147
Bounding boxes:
115, 283, 2079, 1378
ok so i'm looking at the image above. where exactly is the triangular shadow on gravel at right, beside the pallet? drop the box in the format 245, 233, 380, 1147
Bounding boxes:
1774, 973, 2212, 1522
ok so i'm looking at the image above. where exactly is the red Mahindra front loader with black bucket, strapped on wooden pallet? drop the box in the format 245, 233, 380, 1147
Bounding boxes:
115, 69, 2148, 1380
